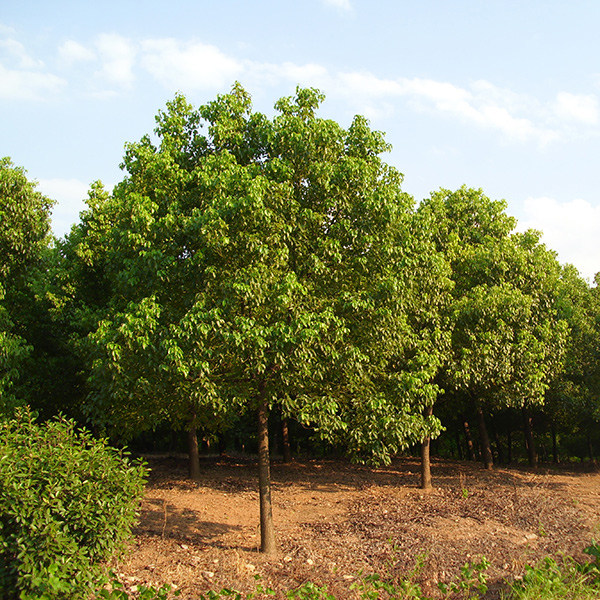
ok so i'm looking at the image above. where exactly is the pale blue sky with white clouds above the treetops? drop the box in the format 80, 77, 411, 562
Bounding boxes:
0, 0, 600, 281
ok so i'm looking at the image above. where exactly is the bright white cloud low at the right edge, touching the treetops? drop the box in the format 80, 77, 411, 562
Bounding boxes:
518, 197, 600, 281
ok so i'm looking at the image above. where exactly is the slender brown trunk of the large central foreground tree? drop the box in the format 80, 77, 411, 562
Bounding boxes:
258, 383, 277, 554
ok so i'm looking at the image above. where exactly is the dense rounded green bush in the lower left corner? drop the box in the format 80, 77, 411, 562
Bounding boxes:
0, 410, 146, 600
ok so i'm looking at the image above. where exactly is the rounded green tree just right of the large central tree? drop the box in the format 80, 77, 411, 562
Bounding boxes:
419, 187, 566, 468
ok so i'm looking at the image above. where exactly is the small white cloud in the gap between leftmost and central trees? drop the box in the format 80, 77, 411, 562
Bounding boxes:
37, 179, 89, 237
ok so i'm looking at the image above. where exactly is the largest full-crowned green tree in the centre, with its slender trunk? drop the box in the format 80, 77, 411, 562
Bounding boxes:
71, 85, 443, 553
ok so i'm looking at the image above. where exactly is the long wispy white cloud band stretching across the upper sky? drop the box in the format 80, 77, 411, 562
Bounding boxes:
0, 28, 600, 146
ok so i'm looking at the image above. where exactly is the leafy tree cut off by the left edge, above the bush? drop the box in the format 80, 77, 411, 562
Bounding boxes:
0, 158, 52, 414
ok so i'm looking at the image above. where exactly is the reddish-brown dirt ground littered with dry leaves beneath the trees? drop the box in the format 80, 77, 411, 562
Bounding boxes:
111, 458, 600, 599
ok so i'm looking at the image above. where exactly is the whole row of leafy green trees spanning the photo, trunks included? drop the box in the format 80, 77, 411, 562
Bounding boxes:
0, 85, 600, 552
